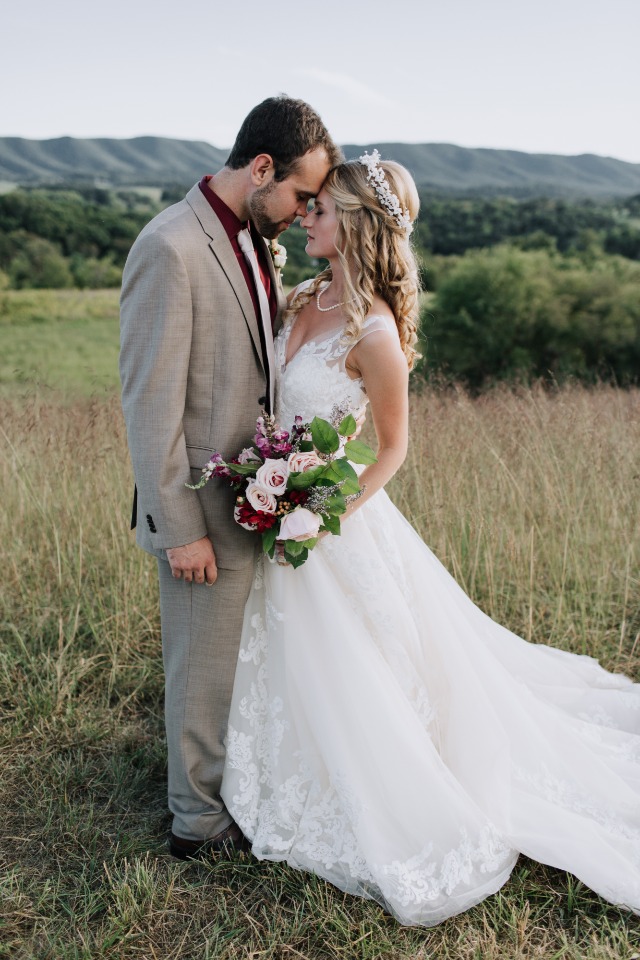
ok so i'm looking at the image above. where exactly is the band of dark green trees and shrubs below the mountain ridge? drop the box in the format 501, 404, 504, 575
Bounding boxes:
0, 188, 640, 389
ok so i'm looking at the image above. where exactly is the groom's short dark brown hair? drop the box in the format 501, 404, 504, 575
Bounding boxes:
226, 94, 342, 180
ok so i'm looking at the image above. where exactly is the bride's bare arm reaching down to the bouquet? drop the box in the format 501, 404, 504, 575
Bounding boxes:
343, 330, 409, 519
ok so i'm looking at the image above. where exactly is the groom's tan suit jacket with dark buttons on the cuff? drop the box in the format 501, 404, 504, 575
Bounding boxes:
120, 184, 285, 569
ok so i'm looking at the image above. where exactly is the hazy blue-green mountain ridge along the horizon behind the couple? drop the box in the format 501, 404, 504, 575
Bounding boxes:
0, 137, 640, 199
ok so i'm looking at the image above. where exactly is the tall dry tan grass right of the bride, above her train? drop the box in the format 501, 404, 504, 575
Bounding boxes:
390, 385, 640, 679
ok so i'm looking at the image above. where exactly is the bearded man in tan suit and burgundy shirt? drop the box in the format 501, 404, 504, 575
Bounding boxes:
120, 96, 340, 859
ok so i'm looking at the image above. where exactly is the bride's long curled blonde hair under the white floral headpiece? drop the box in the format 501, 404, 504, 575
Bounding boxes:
287, 160, 420, 369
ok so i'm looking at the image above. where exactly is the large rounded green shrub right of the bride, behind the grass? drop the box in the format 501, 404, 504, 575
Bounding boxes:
422, 246, 640, 388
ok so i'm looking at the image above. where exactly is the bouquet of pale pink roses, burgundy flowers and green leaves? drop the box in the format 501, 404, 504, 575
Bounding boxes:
186, 407, 376, 567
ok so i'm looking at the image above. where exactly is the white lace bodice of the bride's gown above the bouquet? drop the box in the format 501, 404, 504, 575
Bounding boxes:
275, 284, 396, 430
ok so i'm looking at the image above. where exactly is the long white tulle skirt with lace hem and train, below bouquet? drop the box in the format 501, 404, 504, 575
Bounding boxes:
222, 492, 640, 926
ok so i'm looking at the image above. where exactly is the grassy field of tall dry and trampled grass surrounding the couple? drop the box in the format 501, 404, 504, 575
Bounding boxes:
0, 293, 640, 960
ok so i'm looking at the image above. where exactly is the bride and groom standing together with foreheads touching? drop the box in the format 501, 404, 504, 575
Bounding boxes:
121, 97, 640, 925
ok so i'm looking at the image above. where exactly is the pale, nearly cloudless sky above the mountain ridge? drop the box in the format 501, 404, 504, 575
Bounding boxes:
5, 0, 640, 163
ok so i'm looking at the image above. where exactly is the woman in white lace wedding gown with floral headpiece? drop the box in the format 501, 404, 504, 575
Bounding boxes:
222, 151, 640, 926
